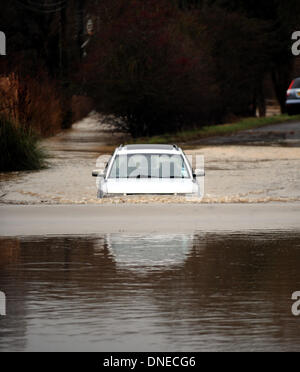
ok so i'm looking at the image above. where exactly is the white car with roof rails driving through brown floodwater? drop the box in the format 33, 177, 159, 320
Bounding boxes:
92, 145, 204, 198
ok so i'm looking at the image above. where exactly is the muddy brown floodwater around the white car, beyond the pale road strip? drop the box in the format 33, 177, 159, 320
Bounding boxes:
0, 114, 300, 204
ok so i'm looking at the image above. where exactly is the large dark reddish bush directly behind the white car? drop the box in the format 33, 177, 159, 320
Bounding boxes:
84, 0, 217, 137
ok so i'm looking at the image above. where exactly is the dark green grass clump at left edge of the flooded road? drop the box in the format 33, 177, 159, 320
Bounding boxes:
0, 117, 46, 172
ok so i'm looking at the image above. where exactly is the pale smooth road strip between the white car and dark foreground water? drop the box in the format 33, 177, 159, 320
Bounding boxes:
0, 203, 300, 236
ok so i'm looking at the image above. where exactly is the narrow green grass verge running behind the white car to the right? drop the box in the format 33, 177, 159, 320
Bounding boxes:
132, 115, 300, 144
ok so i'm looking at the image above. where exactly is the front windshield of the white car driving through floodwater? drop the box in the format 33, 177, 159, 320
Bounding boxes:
108, 154, 189, 178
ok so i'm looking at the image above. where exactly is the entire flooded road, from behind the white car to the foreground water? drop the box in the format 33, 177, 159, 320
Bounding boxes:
0, 114, 300, 351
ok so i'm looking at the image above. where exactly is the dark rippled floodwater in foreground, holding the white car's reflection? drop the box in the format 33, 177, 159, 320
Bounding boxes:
0, 231, 300, 351
